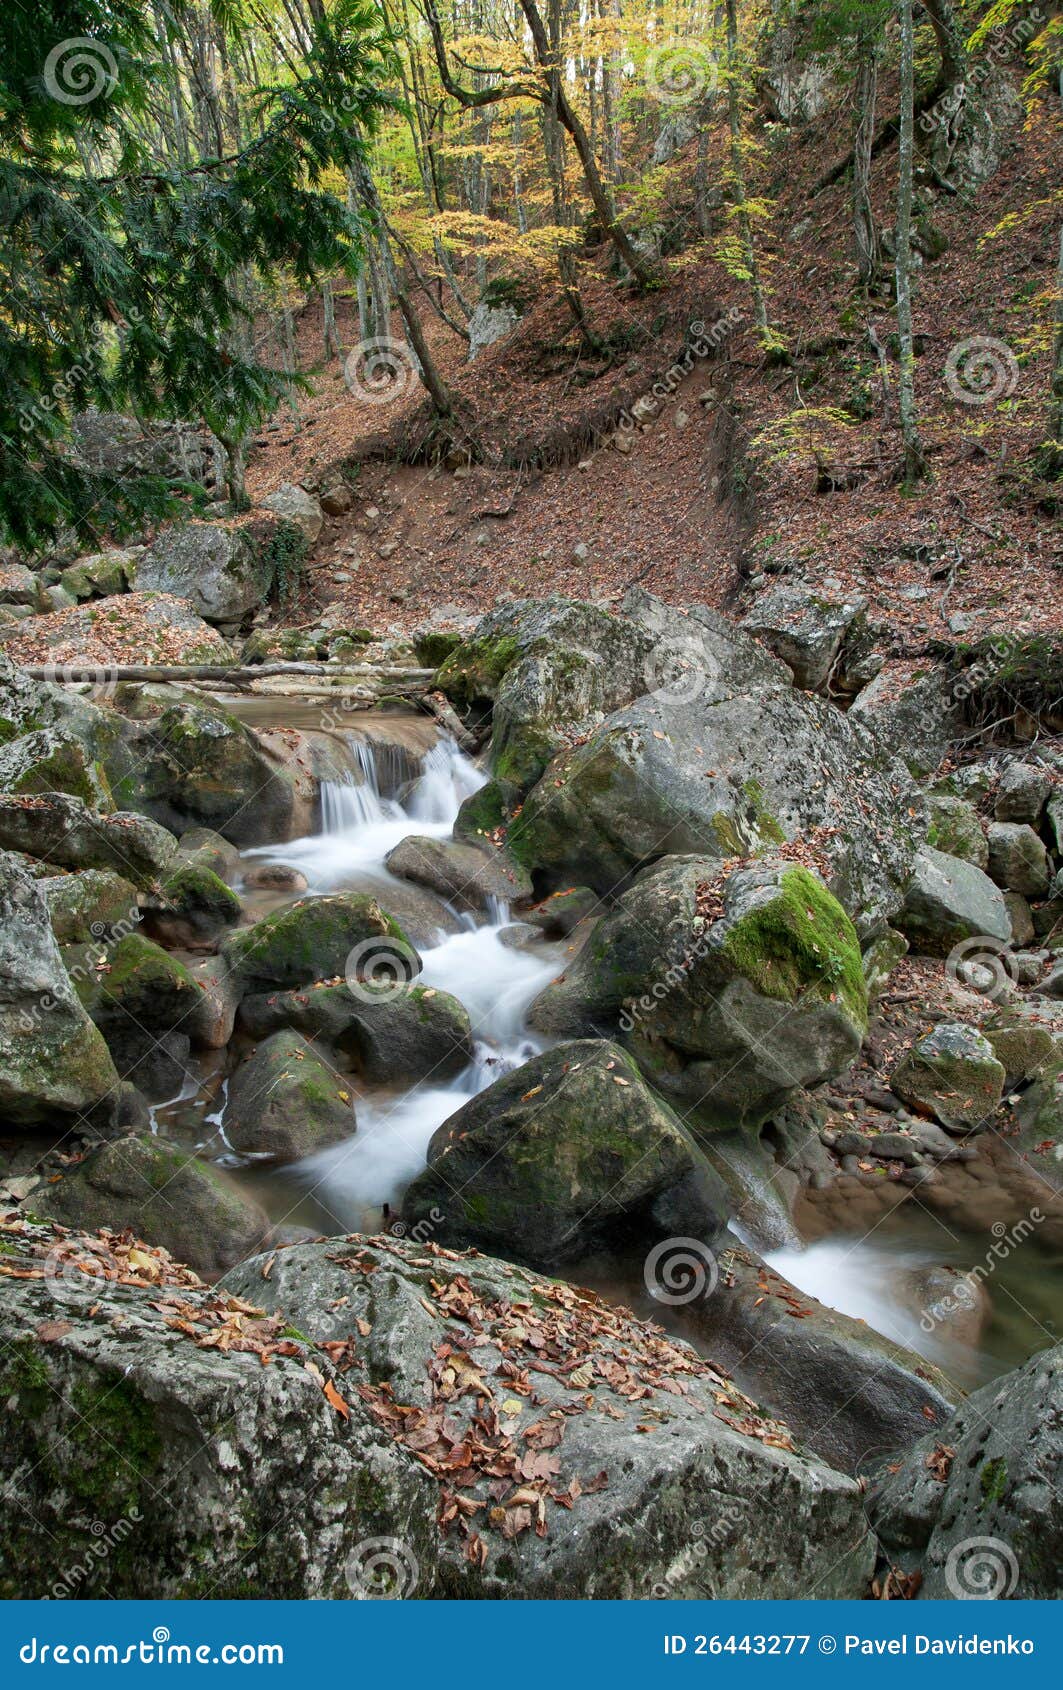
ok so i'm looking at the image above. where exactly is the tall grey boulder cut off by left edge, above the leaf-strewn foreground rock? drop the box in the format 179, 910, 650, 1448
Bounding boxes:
0, 852, 118, 1134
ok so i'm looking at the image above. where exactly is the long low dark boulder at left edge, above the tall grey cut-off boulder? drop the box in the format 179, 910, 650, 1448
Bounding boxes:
0, 793, 177, 887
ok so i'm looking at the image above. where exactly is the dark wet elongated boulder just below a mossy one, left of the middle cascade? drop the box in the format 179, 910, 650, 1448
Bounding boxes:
240, 982, 473, 1085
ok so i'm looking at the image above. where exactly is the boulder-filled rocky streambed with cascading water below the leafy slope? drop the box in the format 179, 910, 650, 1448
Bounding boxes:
0, 593, 1063, 1597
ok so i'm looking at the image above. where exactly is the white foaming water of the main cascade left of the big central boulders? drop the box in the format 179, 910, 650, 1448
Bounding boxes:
263, 739, 559, 1229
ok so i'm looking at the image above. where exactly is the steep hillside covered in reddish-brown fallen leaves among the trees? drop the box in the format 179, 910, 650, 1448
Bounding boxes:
248, 79, 1063, 641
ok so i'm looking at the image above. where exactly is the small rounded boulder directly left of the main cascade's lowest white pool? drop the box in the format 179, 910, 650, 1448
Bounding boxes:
225, 1028, 355, 1161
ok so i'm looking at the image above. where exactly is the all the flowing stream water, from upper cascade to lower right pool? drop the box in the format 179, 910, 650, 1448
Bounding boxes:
155, 719, 1063, 1386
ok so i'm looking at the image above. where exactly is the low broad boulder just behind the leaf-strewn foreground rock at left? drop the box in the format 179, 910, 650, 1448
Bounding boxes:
35, 1134, 270, 1274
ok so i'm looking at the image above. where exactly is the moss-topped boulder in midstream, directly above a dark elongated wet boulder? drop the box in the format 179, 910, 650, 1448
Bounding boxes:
221, 892, 421, 992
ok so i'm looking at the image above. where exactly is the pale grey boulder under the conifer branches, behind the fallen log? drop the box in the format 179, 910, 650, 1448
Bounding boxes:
137, 522, 272, 622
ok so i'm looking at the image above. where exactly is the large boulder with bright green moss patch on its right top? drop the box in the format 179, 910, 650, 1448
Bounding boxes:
531, 857, 867, 1132
